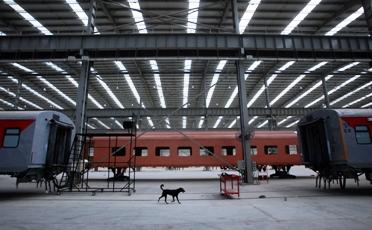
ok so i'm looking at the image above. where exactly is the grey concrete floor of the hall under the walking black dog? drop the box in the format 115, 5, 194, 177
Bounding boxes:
0, 168, 372, 230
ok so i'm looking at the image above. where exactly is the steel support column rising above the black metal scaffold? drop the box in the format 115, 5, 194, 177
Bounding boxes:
75, 0, 96, 133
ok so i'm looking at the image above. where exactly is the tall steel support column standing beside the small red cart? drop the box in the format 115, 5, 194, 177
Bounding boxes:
231, 0, 253, 184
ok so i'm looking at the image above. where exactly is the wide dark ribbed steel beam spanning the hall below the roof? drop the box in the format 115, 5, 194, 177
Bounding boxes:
0, 34, 372, 62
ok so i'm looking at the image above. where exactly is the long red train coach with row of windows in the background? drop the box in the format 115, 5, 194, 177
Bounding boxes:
90, 131, 301, 177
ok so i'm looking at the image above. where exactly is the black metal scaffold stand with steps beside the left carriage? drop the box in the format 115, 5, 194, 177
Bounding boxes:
57, 118, 137, 195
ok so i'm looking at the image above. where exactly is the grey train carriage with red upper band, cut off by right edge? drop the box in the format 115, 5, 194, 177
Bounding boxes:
298, 109, 372, 187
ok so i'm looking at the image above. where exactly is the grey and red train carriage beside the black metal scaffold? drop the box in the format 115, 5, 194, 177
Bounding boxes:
0, 111, 74, 182
